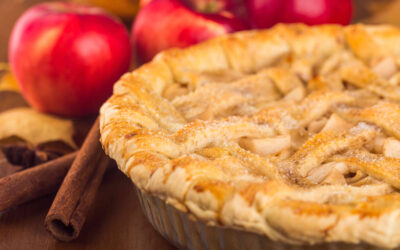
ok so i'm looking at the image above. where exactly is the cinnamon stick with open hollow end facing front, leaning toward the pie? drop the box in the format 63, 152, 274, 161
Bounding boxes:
45, 119, 110, 241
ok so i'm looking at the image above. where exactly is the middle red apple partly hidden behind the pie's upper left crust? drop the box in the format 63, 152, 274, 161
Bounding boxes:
132, 0, 246, 62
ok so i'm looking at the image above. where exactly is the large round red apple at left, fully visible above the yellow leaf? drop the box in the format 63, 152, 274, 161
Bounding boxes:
9, 3, 131, 116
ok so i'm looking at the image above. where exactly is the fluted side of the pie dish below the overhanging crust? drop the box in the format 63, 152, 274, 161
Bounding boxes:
134, 186, 381, 250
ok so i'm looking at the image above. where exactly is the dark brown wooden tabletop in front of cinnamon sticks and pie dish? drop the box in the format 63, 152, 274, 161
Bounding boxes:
0, 166, 174, 250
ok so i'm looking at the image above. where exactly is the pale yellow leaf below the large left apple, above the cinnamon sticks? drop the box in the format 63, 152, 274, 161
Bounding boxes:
0, 108, 77, 149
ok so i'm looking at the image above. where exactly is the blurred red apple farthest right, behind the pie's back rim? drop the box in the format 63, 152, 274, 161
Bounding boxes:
282, 0, 353, 25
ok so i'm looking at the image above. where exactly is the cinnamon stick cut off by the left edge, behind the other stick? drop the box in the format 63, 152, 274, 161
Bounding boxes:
0, 153, 77, 211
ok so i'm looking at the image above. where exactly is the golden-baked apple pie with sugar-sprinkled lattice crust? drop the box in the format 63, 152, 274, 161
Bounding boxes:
100, 24, 400, 249
